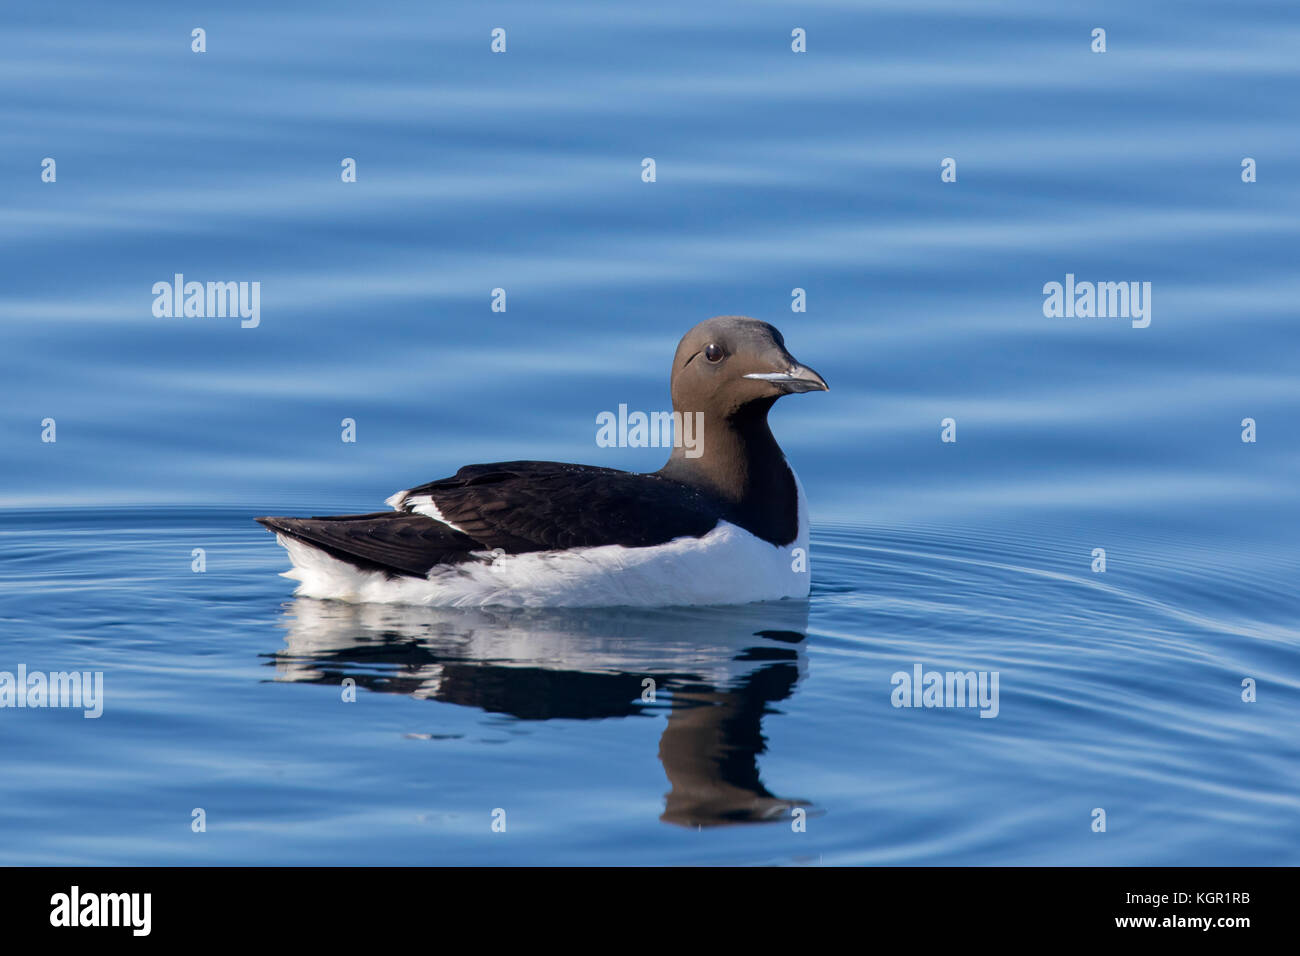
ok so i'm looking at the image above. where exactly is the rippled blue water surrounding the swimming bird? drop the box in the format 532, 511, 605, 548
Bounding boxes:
0, 0, 1300, 865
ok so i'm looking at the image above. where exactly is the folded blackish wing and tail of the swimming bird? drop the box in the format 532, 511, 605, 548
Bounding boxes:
257, 462, 723, 576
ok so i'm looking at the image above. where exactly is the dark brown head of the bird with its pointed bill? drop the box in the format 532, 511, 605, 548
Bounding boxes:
672, 315, 828, 420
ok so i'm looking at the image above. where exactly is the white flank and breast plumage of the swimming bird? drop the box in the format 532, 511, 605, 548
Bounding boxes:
276, 471, 811, 607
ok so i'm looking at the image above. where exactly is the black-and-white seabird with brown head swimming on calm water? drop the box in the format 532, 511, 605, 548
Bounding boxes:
256, 316, 828, 606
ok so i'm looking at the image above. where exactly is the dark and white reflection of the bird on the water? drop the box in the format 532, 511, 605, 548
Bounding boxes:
263, 598, 807, 827
